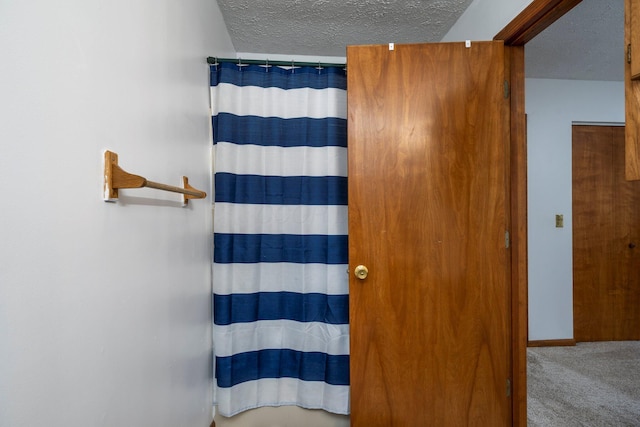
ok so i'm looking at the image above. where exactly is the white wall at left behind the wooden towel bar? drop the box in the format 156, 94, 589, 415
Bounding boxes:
0, 0, 235, 427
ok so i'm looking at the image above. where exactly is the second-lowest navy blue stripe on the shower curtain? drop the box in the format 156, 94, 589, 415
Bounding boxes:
213, 292, 349, 325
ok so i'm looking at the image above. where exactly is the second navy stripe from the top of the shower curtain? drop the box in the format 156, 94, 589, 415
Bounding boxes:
212, 113, 347, 147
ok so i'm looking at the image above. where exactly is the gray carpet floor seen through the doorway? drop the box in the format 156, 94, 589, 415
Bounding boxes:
527, 341, 640, 427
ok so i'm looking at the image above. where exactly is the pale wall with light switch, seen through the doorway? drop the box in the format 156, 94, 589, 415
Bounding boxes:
525, 79, 624, 341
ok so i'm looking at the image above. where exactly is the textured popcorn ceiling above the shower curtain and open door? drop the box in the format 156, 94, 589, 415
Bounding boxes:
218, 0, 471, 56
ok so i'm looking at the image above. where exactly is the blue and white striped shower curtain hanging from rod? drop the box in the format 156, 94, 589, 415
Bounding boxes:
211, 63, 349, 416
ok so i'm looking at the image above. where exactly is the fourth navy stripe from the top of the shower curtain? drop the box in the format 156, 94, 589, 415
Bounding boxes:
213, 233, 349, 264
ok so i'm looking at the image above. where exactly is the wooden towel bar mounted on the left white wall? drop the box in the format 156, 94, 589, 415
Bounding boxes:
104, 150, 207, 205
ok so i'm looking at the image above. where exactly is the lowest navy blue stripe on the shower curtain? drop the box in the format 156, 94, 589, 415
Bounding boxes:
216, 349, 349, 387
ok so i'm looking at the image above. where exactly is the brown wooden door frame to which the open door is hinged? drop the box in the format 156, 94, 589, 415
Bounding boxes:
493, 0, 582, 427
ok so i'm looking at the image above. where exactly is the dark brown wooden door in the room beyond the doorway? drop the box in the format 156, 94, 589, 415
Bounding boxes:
573, 126, 640, 341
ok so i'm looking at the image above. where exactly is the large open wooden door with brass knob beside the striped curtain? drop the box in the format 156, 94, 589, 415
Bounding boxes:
347, 42, 511, 427
